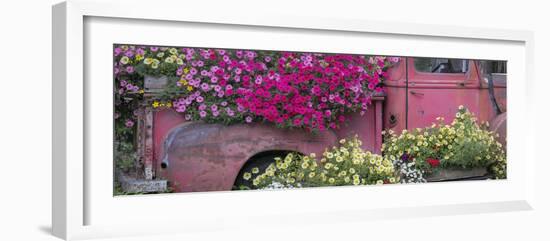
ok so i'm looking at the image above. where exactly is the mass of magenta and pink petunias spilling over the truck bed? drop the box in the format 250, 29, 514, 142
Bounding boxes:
114, 46, 399, 131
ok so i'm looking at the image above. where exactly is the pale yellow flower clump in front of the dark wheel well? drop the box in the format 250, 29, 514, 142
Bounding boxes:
248, 136, 399, 188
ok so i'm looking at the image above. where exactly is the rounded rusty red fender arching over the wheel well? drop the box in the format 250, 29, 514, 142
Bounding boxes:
157, 122, 337, 192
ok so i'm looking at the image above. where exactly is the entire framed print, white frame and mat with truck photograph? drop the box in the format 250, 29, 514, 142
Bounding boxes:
53, 0, 534, 239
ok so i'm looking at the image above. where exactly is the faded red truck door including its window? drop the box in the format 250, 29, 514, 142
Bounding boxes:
406, 57, 480, 129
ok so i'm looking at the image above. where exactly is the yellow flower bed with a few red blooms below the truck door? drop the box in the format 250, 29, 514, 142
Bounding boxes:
382, 106, 506, 181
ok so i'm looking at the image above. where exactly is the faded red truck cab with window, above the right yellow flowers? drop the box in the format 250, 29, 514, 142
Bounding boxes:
384, 57, 506, 136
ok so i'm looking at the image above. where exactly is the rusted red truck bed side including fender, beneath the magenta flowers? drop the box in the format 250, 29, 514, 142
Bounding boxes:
154, 101, 384, 192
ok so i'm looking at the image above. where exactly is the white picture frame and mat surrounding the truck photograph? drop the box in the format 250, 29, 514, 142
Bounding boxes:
52, 0, 535, 240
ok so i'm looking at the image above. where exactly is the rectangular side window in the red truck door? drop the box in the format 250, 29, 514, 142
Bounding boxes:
414, 58, 469, 73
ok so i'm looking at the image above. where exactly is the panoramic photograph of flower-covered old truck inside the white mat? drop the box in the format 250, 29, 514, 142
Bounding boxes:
113, 44, 507, 196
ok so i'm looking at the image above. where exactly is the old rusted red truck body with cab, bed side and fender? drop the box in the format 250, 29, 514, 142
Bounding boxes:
129, 57, 506, 192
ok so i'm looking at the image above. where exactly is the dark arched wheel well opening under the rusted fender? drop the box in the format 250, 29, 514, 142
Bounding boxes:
233, 150, 301, 190
